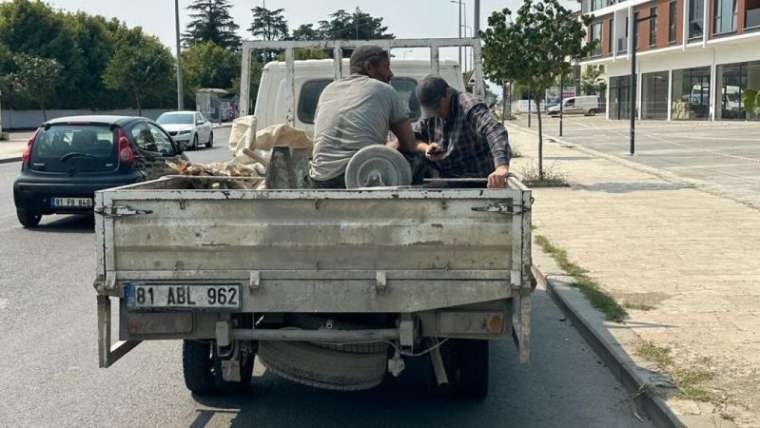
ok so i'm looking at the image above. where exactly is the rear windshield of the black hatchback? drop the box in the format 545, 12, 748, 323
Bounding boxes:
31, 125, 119, 174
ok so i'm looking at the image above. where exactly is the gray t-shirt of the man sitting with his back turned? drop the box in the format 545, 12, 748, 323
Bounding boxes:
309, 75, 409, 181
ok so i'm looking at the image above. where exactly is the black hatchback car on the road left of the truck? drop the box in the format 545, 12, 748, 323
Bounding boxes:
13, 116, 186, 228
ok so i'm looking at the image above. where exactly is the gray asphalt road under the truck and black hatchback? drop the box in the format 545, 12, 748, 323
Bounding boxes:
0, 132, 648, 427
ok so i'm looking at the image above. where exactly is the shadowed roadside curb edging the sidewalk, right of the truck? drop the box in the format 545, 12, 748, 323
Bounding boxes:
533, 265, 686, 428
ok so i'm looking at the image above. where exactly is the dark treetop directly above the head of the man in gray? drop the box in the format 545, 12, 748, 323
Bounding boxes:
317, 7, 395, 40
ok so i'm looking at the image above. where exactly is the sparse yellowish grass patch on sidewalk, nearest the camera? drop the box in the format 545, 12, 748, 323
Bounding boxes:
635, 340, 718, 402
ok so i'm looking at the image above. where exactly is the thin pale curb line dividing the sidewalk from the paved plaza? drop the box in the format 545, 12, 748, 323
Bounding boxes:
505, 123, 760, 209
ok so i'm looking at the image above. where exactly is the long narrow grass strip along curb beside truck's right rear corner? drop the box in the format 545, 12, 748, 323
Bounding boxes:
536, 235, 628, 322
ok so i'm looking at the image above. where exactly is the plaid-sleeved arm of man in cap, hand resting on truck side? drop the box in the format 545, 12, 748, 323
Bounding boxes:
470, 104, 512, 188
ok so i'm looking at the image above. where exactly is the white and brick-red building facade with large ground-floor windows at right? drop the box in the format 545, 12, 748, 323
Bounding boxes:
581, 0, 760, 121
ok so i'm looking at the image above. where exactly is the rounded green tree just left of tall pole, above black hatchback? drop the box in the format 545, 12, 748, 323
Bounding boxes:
103, 27, 176, 115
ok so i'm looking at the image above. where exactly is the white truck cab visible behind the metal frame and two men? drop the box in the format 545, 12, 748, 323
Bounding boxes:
254, 59, 464, 134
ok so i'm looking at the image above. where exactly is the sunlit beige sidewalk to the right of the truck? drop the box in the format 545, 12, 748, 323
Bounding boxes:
507, 123, 760, 427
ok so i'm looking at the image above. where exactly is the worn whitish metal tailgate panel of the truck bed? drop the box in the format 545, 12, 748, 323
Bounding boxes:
96, 177, 530, 312
